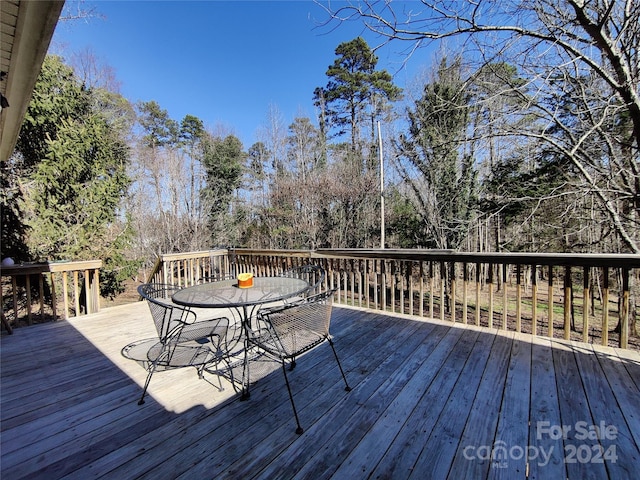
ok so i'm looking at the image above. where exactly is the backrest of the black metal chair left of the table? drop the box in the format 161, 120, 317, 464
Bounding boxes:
138, 283, 196, 342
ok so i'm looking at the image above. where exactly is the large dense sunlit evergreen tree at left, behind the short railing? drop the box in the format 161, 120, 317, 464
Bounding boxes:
12, 57, 135, 294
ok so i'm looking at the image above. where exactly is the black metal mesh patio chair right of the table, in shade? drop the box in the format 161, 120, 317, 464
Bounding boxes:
245, 289, 351, 434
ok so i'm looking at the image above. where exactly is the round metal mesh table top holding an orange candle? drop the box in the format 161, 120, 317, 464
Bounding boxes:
172, 277, 309, 308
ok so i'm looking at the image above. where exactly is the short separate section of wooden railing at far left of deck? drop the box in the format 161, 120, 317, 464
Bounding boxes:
0, 260, 102, 332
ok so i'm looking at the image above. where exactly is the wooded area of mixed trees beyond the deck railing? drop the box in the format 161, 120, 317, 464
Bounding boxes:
2, 0, 640, 300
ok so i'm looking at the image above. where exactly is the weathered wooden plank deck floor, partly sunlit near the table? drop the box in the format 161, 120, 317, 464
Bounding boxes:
0, 303, 640, 480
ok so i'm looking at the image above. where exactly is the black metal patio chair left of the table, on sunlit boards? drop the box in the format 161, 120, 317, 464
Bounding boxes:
122, 283, 230, 405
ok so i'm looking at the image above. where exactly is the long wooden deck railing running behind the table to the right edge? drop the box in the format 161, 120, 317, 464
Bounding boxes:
152, 249, 640, 348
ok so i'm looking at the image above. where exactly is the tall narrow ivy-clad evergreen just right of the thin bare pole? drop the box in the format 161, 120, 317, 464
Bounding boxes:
398, 59, 476, 249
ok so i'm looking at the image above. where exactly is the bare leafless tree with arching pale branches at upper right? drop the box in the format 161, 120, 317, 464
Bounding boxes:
325, 0, 640, 253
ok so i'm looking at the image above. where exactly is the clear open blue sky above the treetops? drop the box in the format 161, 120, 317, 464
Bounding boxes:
51, 0, 430, 149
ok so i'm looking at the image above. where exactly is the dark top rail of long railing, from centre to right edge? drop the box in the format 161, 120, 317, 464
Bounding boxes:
312, 248, 640, 268
